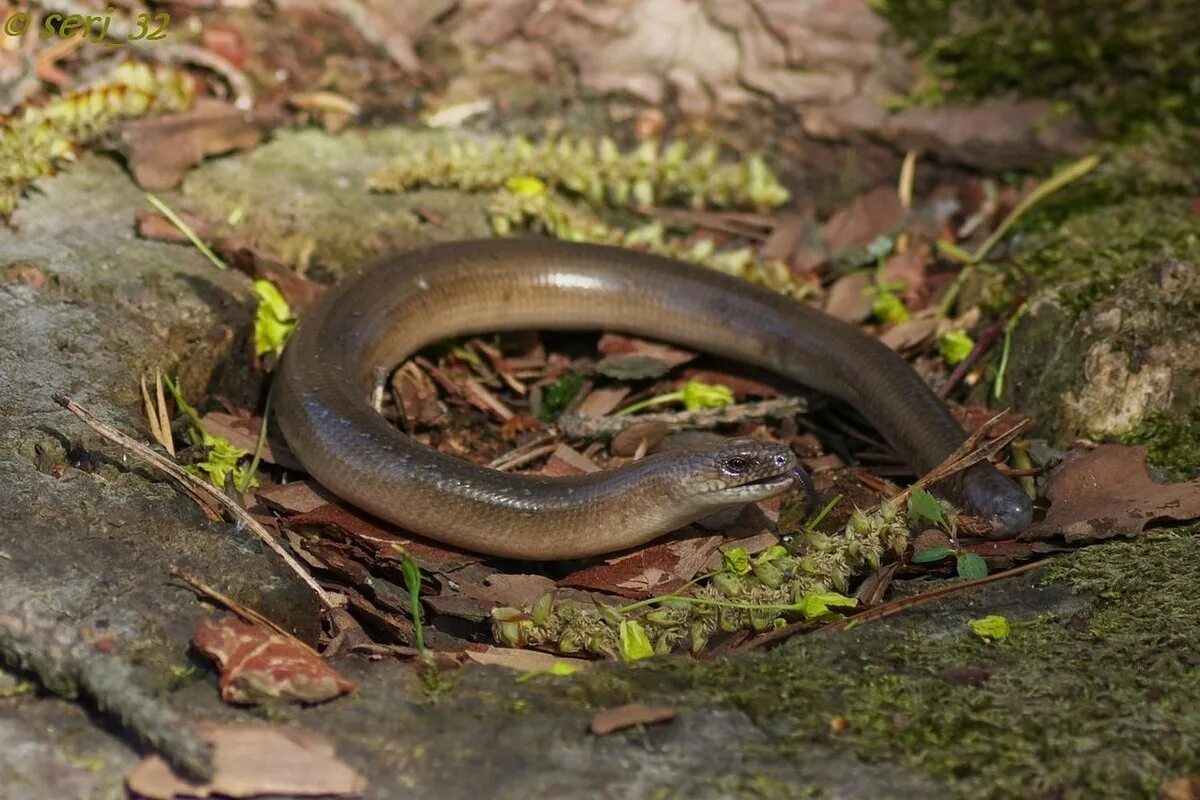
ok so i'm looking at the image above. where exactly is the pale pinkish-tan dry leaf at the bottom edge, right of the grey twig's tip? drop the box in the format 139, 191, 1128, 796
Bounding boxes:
126, 722, 367, 800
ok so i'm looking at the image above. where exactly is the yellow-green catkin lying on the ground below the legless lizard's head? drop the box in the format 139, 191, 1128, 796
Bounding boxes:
492, 503, 908, 660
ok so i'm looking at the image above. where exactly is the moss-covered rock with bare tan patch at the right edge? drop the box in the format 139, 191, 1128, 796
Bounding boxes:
992, 139, 1200, 471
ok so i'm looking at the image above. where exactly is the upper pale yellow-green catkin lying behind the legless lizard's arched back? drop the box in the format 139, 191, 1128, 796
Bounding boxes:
371, 137, 787, 210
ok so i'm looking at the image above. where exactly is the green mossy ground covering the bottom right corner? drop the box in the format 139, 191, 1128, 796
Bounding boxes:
554, 528, 1200, 798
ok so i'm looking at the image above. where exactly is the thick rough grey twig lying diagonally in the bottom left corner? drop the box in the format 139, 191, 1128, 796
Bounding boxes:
0, 601, 212, 782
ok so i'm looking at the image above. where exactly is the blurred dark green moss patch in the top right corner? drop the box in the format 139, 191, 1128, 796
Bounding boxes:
871, 0, 1200, 136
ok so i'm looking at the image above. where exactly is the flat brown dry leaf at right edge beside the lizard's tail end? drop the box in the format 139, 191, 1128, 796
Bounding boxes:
1021, 445, 1200, 543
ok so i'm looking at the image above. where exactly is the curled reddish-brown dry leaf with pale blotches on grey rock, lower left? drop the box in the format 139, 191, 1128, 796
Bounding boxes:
192, 616, 354, 705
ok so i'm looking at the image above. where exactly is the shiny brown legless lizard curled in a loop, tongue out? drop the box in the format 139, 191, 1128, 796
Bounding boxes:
275, 239, 1031, 560
